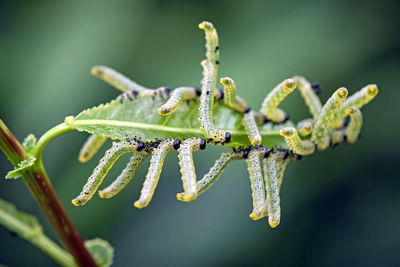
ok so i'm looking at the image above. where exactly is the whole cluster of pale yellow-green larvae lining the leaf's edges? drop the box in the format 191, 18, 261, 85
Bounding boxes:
72, 22, 378, 227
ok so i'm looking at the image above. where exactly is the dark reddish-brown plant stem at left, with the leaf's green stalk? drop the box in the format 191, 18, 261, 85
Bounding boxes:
0, 120, 97, 267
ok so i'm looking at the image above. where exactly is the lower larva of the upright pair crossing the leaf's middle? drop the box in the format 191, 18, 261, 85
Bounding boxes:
199, 60, 231, 143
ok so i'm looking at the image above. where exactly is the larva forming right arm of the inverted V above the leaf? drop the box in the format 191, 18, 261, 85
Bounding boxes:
293, 76, 322, 119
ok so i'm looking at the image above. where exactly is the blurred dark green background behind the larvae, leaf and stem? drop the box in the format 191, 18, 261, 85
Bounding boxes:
0, 0, 400, 266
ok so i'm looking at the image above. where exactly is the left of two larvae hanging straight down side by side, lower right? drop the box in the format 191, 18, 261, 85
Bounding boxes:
246, 149, 266, 220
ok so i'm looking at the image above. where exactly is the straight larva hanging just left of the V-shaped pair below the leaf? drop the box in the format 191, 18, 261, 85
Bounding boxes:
134, 139, 175, 209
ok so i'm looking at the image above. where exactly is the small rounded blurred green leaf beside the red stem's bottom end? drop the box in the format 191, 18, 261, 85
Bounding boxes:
85, 238, 114, 267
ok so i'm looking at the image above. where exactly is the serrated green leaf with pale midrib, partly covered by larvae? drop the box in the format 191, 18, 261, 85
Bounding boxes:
65, 96, 293, 148
